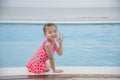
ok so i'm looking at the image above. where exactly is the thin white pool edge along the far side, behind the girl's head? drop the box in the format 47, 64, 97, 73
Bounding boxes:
0, 20, 120, 24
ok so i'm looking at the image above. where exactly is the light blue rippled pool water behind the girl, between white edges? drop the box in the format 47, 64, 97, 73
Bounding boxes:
0, 23, 120, 67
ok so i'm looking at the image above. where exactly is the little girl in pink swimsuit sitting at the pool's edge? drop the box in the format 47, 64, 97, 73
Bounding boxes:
26, 23, 63, 74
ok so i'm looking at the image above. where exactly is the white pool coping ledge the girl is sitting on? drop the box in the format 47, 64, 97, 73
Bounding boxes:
0, 66, 120, 77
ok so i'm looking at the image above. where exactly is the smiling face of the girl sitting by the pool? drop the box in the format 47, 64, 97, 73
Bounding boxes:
45, 26, 58, 40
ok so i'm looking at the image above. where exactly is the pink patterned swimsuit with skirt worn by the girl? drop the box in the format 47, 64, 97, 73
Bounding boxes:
26, 40, 55, 74
